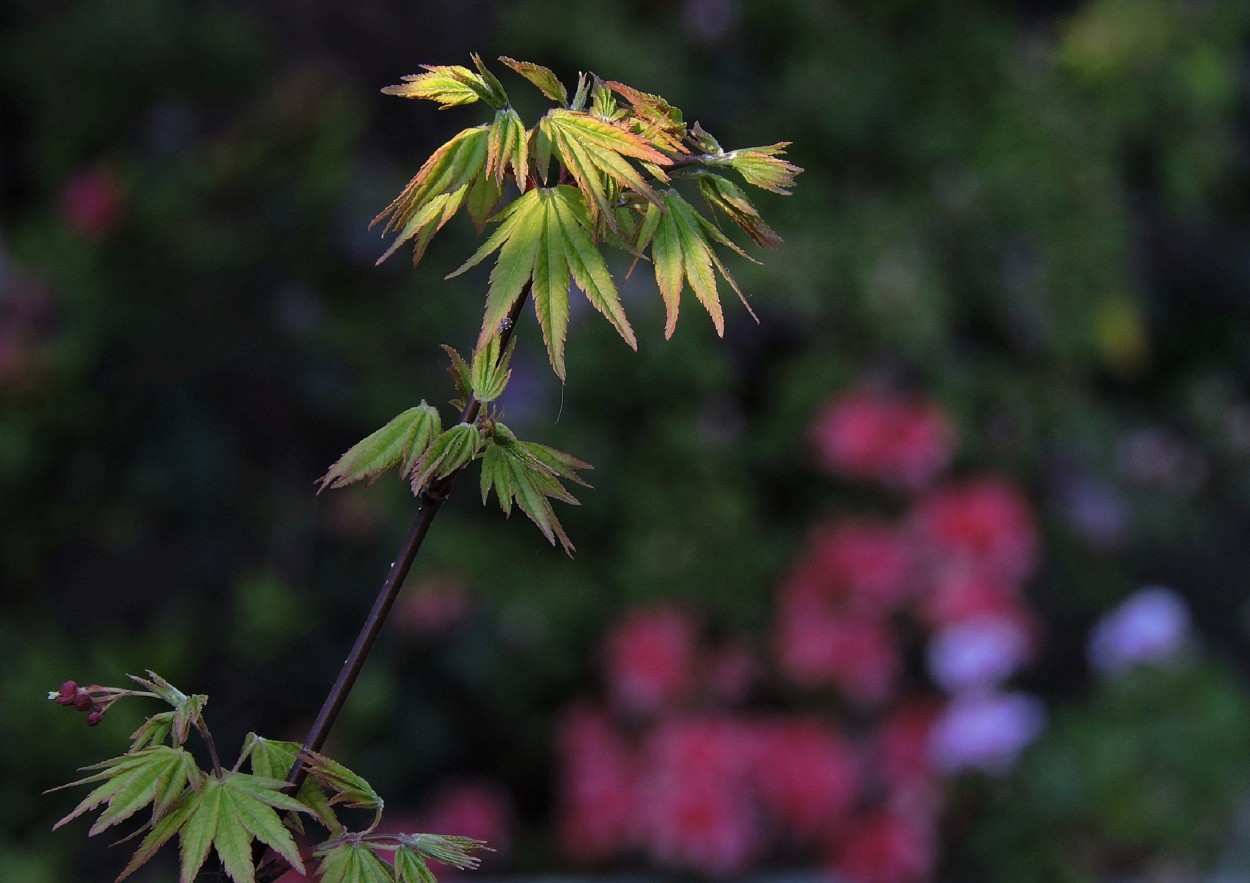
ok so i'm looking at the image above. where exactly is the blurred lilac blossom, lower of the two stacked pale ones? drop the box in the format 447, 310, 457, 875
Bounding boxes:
929, 693, 1046, 774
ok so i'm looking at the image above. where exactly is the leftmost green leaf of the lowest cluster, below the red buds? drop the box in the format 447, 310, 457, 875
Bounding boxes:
53, 745, 203, 837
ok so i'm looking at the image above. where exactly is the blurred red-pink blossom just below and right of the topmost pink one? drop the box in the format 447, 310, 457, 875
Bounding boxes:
913, 478, 1038, 583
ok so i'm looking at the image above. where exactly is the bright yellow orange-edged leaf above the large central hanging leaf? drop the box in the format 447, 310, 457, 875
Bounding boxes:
539, 108, 671, 223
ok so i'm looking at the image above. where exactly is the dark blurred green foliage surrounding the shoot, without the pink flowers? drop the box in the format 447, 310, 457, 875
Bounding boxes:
7, 0, 1250, 880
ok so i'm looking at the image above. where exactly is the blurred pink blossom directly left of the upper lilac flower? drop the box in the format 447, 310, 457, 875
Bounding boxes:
775, 593, 899, 704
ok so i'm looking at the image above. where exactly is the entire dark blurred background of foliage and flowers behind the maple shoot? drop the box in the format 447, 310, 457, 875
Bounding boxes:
7, 0, 1250, 883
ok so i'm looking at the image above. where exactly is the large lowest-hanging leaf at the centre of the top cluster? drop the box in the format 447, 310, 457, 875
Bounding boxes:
450, 185, 638, 379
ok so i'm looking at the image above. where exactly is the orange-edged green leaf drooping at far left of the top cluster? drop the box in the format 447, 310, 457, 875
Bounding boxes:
369, 125, 490, 266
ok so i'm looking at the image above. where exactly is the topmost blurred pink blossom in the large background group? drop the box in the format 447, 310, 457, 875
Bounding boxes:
811, 386, 955, 490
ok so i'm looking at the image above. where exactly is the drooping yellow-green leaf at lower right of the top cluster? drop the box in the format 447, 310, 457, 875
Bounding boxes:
638, 190, 755, 338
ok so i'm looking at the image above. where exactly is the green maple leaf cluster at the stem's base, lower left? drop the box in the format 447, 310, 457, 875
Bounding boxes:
54, 672, 484, 883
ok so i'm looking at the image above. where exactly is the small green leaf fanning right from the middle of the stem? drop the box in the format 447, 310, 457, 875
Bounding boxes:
481, 423, 591, 555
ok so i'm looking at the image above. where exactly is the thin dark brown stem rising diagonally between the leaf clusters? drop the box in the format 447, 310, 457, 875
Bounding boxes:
256, 283, 530, 883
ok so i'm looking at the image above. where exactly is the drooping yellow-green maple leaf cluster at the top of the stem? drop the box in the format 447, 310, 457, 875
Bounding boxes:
375, 56, 801, 379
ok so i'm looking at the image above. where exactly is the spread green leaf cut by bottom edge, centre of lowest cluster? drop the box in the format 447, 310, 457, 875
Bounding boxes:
179, 772, 311, 883
